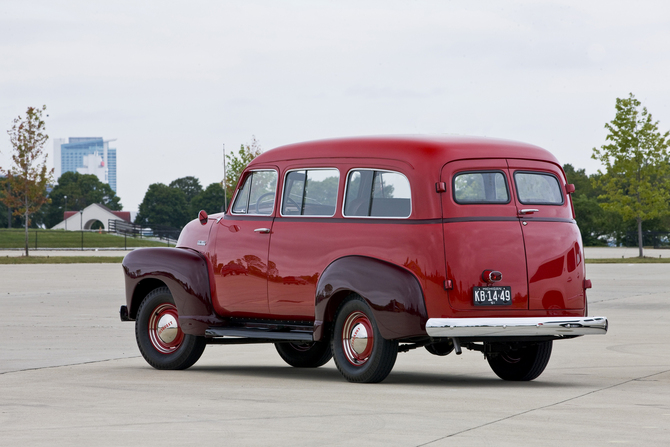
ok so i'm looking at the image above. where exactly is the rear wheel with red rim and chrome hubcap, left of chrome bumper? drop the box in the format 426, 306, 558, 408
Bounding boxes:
331, 295, 398, 383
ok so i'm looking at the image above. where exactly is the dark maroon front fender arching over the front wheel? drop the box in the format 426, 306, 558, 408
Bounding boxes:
123, 248, 222, 335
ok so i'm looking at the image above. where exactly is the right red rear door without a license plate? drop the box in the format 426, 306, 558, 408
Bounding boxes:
508, 160, 584, 309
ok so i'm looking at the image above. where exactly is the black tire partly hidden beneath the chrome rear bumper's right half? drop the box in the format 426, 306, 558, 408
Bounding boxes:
487, 341, 552, 381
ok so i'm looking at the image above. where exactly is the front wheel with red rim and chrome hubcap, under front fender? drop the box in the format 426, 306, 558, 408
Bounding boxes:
135, 287, 205, 370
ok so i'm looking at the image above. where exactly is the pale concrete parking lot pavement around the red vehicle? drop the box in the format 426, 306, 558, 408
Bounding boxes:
0, 264, 670, 447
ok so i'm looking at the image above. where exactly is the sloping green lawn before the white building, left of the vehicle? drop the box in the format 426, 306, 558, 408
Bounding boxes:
0, 228, 174, 250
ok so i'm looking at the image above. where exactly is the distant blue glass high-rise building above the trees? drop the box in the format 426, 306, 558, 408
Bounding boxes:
54, 137, 117, 192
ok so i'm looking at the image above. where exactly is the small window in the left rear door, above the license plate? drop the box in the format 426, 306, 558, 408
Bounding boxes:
452, 171, 509, 204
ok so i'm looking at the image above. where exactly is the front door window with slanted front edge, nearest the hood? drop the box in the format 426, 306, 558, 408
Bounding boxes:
232, 171, 277, 215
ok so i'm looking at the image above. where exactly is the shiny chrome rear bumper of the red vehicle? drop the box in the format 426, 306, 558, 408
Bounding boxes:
426, 317, 607, 337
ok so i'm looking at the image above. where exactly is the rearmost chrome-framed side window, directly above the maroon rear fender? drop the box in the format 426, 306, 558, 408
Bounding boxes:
344, 169, 412, 217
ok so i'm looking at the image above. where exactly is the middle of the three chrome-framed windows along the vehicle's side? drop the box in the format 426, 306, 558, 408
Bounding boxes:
281, 169, 340, 216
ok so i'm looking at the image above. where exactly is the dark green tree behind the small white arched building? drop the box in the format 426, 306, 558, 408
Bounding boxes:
41, 172, 123, 228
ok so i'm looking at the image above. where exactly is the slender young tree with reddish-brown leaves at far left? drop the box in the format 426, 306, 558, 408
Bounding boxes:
0, 106, 53, 256
